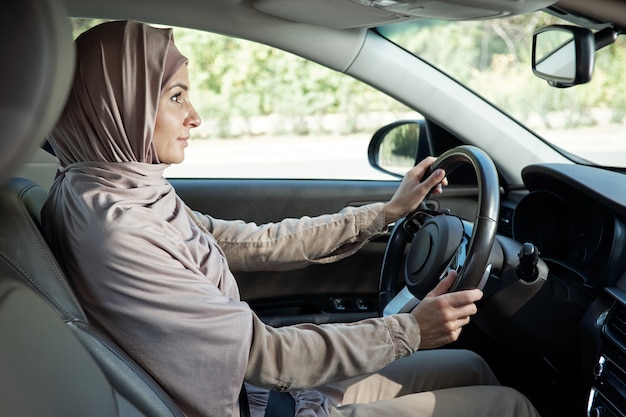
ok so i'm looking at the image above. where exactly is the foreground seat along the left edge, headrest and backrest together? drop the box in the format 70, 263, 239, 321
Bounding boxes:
0, 0, 118, 417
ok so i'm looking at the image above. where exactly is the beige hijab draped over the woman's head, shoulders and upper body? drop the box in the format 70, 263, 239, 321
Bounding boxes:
42, 22, 252, 416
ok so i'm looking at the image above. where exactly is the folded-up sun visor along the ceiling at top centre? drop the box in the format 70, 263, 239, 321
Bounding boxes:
253, 0, 555, 29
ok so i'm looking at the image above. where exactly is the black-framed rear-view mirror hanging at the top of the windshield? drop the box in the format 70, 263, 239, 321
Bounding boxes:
532, 25, 596, 88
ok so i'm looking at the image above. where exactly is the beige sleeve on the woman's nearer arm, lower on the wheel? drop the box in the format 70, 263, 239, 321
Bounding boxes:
245, 314, 421, 391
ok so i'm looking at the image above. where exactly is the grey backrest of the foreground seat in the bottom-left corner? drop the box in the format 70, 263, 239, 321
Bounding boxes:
0, 262, 118, 417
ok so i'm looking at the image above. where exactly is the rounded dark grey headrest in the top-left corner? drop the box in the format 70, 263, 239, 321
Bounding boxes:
0, 0, 75, 182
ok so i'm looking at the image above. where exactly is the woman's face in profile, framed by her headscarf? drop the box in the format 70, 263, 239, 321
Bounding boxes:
152, 65, 201, 164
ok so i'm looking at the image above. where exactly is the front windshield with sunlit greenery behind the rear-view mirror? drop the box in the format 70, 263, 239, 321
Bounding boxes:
378, 13, 626, 167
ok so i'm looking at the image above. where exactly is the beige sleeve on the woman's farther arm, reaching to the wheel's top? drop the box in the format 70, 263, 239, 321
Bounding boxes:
189, 203, 386, 271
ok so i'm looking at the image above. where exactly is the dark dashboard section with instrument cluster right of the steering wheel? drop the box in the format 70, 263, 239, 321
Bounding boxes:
513, 164, 626, 290
